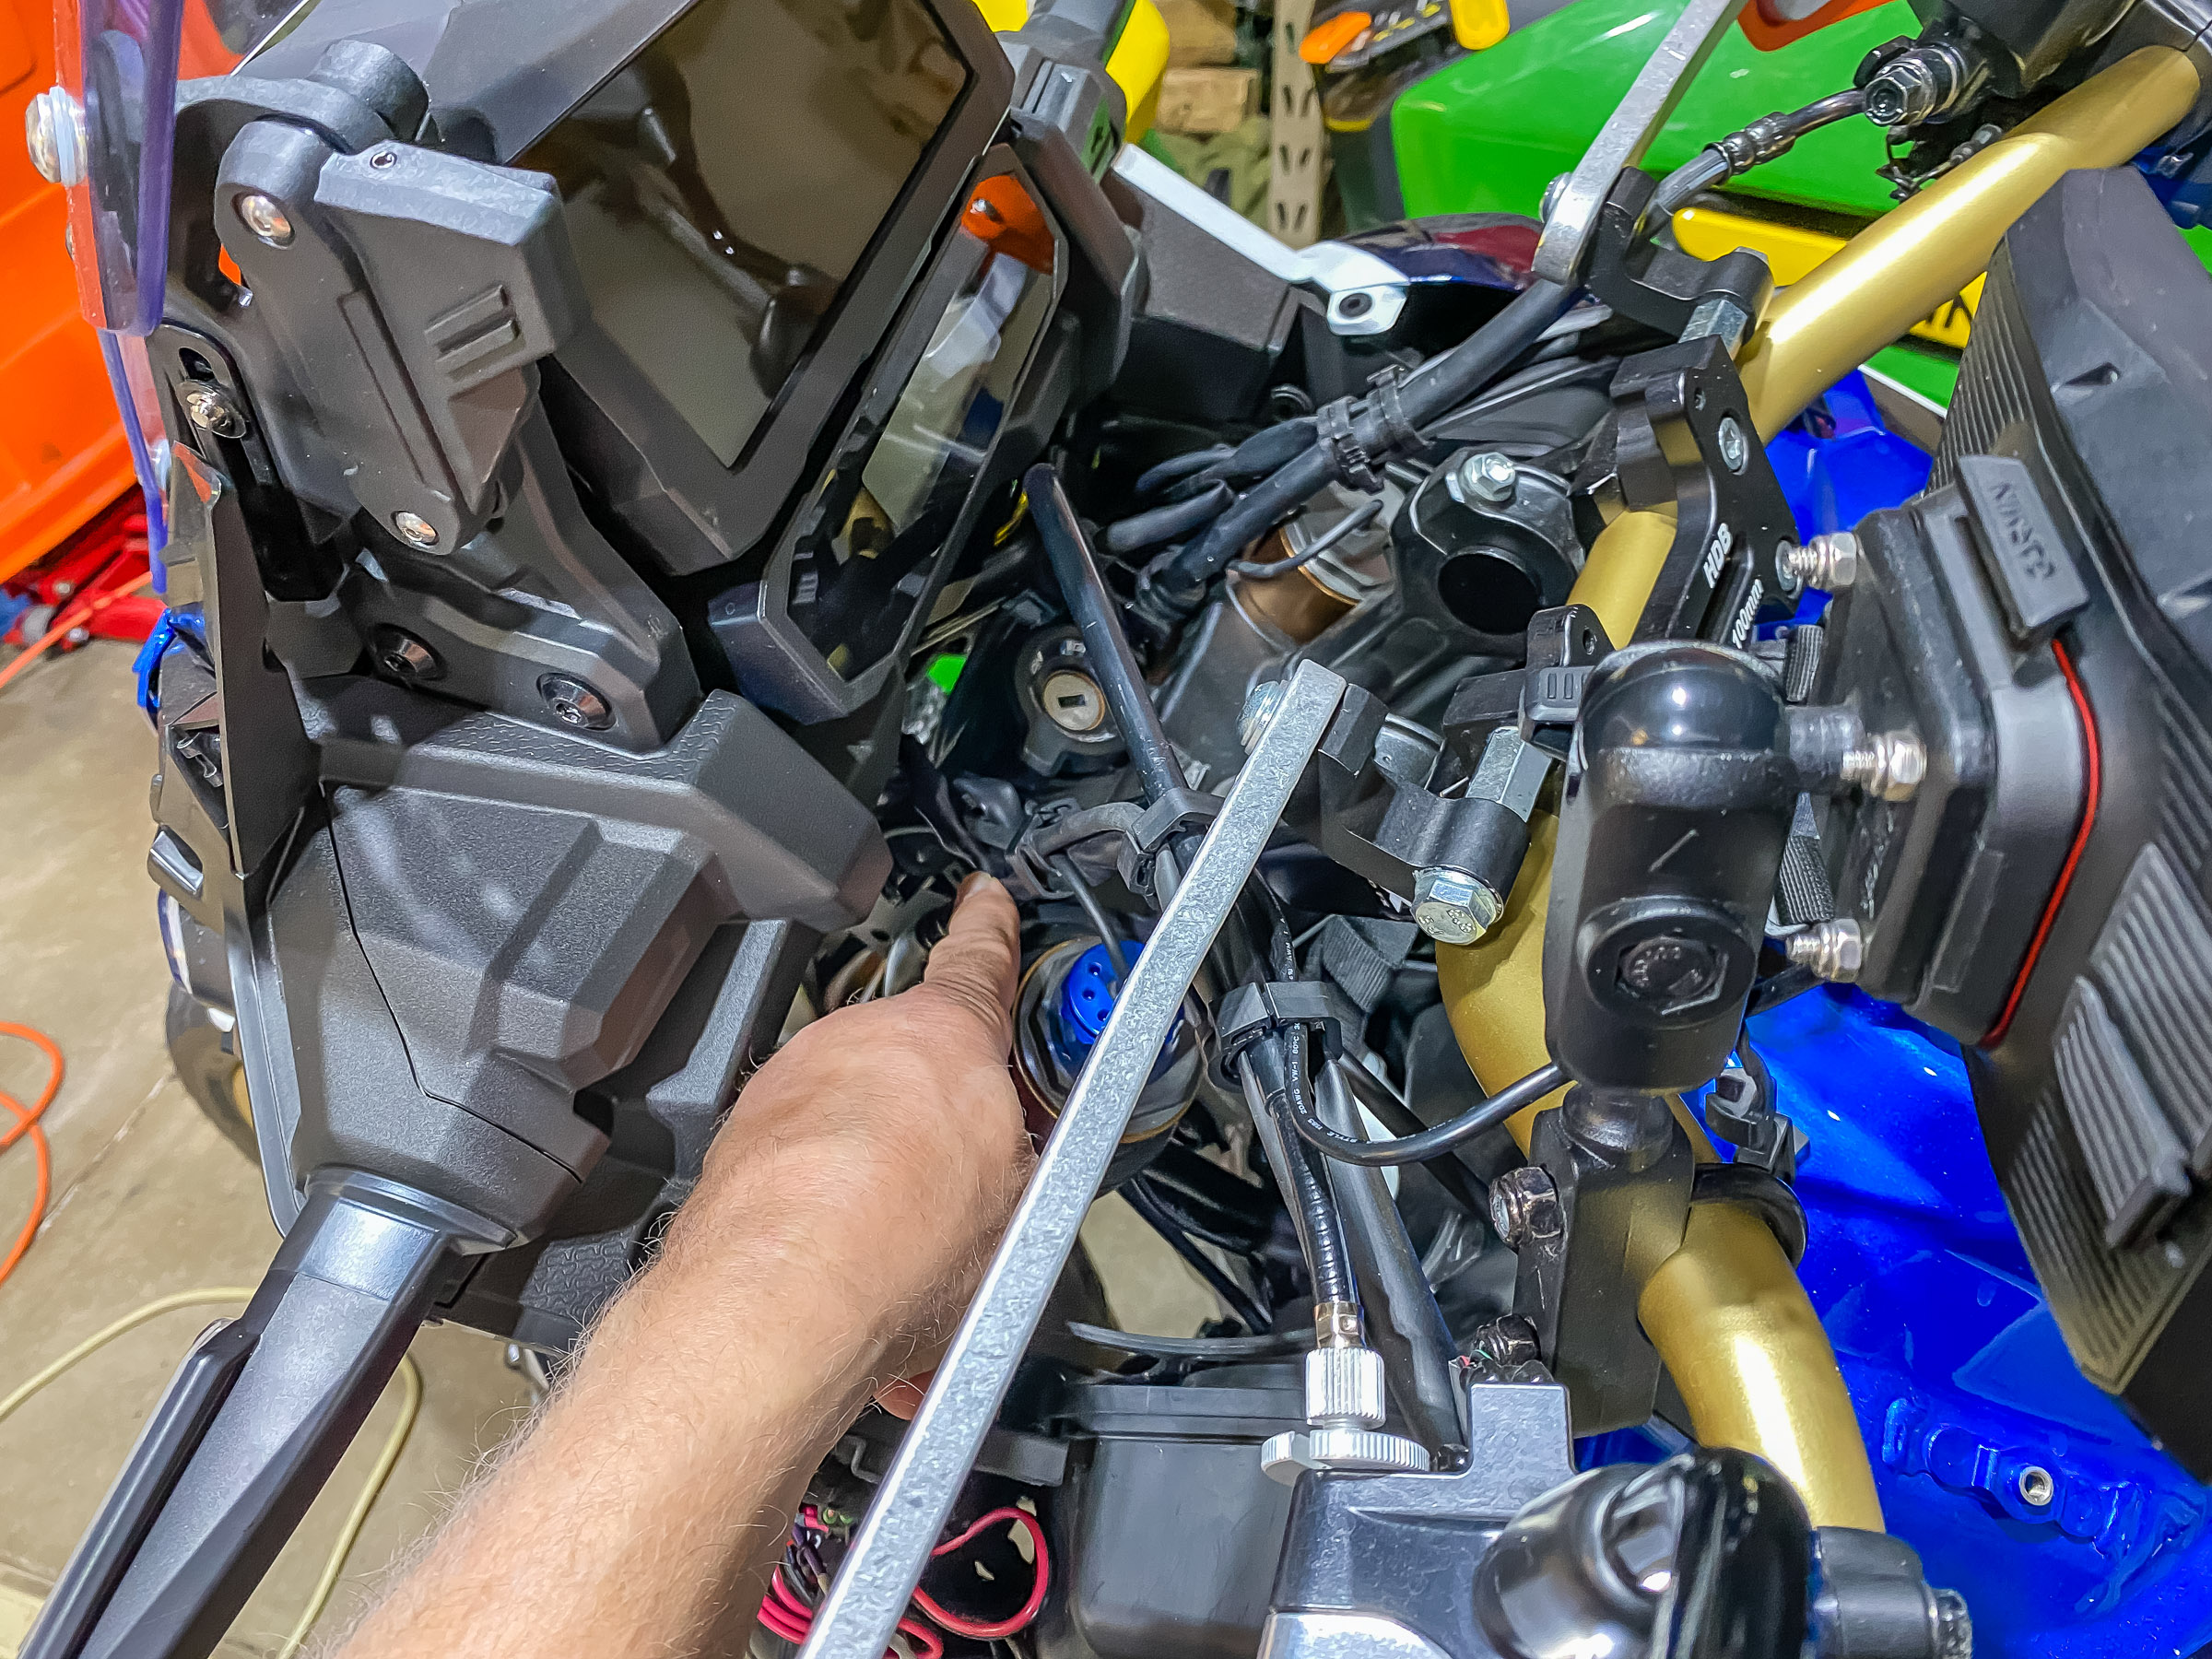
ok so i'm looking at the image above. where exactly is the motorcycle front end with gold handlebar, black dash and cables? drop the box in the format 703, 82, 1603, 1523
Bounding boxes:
24, 0, 2212, 1659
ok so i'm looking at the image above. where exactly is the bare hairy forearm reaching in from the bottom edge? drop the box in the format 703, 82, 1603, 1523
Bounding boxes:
345, 1150, 883, 1659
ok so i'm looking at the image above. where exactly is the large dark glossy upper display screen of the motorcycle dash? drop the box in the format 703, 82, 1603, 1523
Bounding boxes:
518, 0, 967, 466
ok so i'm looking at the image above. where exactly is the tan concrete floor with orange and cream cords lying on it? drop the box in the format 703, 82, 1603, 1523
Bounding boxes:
0, 643, 1215, 1659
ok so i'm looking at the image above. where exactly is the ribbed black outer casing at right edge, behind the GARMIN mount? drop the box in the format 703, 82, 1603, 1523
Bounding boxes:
1936, 168, 2212, 1476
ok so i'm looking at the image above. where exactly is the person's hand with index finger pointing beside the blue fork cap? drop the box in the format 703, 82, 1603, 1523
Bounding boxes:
657, 876, 1033, 1409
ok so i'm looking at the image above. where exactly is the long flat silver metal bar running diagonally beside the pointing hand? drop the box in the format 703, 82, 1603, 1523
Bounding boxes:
801, 662, 1345, 1659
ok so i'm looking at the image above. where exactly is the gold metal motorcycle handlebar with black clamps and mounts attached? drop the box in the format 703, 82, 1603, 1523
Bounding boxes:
1436, 46, 2199, 1528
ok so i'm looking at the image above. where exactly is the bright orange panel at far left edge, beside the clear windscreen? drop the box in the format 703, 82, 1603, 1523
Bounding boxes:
0, 0, 137, 582
